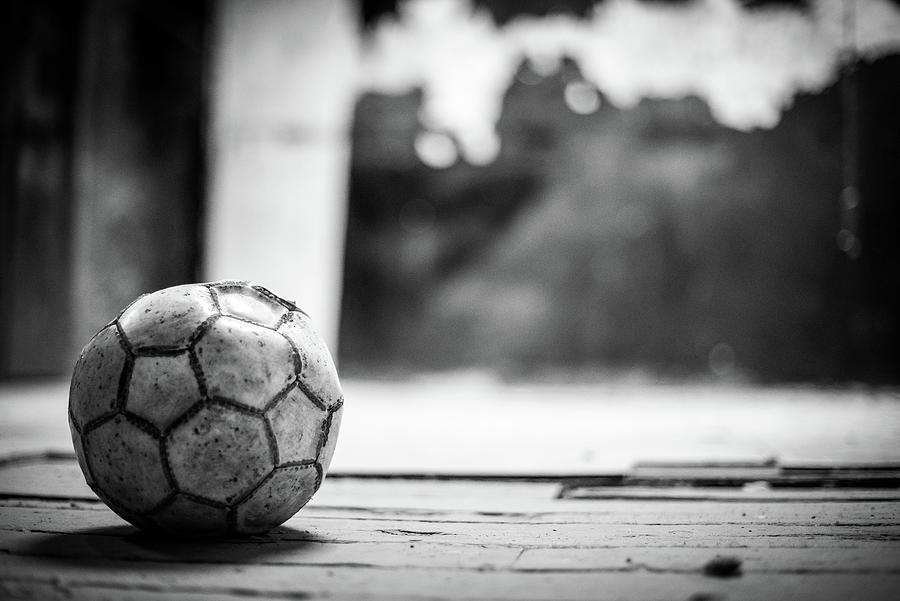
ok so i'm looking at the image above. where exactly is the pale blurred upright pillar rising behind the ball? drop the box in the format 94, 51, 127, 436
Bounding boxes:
203, 0, 359, 352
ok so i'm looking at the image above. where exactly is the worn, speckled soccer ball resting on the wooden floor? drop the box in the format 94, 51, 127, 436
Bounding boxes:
69, 281, 343, 536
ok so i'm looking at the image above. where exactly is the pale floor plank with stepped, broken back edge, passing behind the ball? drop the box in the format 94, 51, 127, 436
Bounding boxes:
0, 455, 900, 525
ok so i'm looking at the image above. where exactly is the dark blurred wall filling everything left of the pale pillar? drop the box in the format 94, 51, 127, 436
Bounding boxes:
0, 0, 208, 377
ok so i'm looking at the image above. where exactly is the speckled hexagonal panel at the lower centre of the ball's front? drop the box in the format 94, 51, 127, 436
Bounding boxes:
166, 403, 274, 504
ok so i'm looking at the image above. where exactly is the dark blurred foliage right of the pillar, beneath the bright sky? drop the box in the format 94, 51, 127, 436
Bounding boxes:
341, 56, 900, 382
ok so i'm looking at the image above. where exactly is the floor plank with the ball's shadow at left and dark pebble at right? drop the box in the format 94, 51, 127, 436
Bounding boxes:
0, 530, 900, 574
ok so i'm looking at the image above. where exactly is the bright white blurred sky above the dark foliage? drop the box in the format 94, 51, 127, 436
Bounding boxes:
360, 0, 900, 168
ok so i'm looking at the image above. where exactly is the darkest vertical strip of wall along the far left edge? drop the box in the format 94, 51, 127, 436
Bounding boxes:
0, 0, 84, 375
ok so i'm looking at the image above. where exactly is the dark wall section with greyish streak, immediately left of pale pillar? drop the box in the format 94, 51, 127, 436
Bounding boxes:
71, 0, 208, 352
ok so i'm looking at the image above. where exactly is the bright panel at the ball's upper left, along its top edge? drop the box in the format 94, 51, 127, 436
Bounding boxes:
119, 284, 216, 350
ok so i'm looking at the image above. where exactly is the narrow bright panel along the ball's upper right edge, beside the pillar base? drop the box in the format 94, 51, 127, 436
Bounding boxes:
278, 311, 343, 407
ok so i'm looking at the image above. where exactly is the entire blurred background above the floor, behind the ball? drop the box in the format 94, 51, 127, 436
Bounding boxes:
0, 0, 900, 385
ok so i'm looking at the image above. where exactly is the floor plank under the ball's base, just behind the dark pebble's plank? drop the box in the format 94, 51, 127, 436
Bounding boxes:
0, 507, 900, 549
